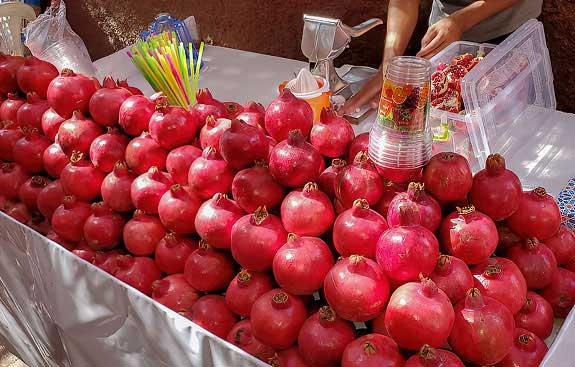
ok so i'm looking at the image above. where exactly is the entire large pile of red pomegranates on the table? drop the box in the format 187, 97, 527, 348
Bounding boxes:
0, 55, 575, 367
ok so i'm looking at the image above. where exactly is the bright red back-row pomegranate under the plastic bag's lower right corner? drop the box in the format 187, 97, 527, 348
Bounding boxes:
46, 69, 100, 118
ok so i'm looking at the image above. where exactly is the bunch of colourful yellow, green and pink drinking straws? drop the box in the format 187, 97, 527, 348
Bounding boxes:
128, 32, 204, 110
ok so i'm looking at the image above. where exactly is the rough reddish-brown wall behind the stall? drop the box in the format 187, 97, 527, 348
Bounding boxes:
66, 0, 575, 112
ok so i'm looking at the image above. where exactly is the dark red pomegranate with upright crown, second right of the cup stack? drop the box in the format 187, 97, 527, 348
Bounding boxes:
469, 154, 522, 221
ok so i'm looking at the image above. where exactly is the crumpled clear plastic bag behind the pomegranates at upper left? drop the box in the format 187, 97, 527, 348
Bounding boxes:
24, 0, 96, 76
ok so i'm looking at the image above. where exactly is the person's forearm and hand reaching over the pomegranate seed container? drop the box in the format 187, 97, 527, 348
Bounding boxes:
417, 0, 520, 59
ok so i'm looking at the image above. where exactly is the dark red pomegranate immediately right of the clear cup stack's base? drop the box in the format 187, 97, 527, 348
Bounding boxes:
423, 152, 473, 202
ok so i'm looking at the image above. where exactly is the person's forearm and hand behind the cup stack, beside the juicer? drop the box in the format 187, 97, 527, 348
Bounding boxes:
339, 0, 419, 114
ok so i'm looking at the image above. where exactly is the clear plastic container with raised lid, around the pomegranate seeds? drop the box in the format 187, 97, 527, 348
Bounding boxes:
428, 20, 556, 172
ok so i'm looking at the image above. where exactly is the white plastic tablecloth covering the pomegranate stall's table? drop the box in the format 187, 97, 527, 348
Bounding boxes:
0, 47, 575, 367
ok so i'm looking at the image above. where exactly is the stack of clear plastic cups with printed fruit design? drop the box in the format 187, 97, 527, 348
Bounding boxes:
368, 56, 433, 182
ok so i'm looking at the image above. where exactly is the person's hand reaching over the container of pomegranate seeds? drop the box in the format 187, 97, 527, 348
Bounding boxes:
417, 17, 463, 59
